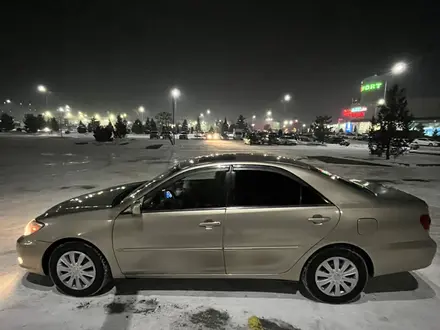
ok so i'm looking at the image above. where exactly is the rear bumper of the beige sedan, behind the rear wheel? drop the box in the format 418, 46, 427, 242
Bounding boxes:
369, 238, 437, 276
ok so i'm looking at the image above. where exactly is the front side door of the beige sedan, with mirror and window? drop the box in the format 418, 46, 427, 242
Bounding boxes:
113, 167, 229, 276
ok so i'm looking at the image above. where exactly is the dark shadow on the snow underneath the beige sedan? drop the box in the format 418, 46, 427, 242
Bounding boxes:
22, 272, 435, 303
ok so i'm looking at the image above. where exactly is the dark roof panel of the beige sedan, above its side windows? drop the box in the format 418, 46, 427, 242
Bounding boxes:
178, 153, 313, 169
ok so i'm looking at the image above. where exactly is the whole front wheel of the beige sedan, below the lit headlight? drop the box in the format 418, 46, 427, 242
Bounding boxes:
49, 242, 111, 297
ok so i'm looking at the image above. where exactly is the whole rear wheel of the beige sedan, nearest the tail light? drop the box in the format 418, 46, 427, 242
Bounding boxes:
301, 247, 368, 304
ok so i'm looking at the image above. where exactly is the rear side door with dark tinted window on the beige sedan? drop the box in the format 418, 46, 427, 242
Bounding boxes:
223, 166, 340, 275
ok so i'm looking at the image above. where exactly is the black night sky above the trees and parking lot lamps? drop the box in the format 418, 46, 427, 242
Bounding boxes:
0, 0, 440, 120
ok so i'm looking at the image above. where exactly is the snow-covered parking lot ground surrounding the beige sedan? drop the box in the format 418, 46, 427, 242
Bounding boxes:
0, 134, 440, 330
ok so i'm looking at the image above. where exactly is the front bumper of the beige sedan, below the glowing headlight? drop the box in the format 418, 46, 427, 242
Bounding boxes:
16, 236, 51, 275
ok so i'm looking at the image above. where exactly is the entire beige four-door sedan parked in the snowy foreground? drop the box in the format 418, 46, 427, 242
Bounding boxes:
17, 154, 436, 303
